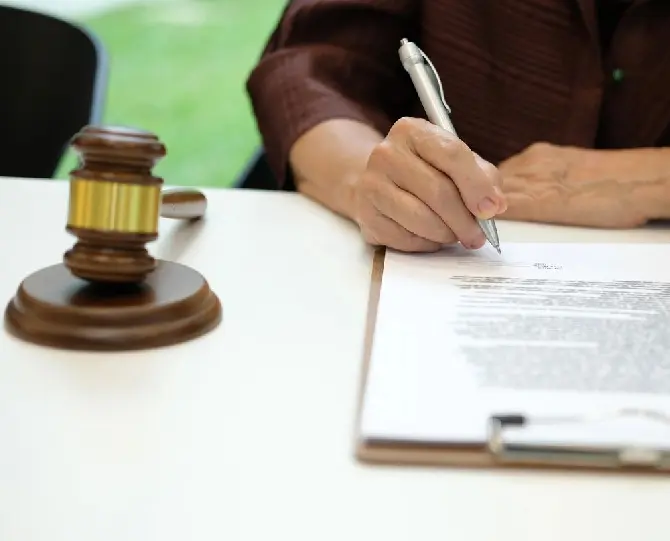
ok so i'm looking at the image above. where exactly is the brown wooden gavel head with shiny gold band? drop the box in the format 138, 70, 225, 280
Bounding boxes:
64, 126, 166, 283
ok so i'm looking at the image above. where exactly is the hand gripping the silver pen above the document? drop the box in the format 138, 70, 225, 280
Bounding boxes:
354, 118, 505, 252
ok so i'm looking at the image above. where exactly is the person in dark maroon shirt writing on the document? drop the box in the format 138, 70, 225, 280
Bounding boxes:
247, 0, 670, 252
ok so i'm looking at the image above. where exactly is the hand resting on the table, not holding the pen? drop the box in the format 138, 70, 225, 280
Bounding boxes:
498, 143, 648, 228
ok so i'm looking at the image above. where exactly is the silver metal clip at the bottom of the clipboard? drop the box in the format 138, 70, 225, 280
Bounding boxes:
488, 409, 670, 470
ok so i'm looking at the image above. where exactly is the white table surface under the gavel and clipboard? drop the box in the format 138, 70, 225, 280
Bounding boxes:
0, 179, 670, 541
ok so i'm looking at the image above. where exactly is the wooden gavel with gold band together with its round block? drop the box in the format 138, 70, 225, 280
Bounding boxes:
5, 126, 221, 351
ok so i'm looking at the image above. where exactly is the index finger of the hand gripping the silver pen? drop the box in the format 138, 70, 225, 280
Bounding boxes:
389, 118, 505, 219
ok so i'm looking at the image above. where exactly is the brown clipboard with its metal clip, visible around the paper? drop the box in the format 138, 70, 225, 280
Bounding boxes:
355, 248, 670, 474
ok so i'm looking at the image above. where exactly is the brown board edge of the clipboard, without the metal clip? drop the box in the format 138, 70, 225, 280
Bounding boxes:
355, 248, 670, 474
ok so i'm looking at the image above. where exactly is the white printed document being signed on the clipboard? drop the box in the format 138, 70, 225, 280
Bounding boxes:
361, 243, 670, 447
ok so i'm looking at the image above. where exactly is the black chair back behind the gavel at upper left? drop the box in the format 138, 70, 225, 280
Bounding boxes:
0, 6, 107, 178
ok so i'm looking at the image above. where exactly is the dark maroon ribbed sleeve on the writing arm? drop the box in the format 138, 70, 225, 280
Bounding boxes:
247, 0, 420, 187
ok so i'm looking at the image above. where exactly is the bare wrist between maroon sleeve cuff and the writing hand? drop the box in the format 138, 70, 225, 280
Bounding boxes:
289, 119, 383, 220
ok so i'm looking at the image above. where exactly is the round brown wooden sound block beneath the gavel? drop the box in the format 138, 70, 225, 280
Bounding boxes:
5, 261, 222, 351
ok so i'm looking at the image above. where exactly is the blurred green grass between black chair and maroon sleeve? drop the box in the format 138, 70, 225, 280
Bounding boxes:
58, 0, 284, 187
